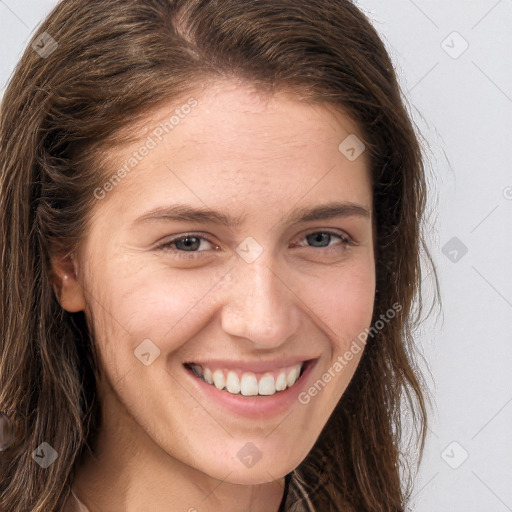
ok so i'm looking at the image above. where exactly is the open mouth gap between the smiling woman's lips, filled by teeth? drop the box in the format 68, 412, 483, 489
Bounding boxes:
184, 359, 313, 397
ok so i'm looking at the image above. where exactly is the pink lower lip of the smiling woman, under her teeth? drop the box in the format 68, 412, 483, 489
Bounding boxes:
185, 359, 317, 418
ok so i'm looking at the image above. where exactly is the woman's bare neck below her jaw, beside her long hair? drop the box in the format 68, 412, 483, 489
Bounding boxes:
73, 378, 285, 512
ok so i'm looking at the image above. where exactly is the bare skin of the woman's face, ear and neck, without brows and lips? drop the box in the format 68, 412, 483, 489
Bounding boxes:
54, 81, 375, 512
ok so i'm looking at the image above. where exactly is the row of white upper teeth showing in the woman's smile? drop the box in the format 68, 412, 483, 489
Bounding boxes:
191, 363, 303, 396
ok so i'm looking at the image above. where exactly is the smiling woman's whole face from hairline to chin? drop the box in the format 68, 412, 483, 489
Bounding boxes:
61, 82, 375, 484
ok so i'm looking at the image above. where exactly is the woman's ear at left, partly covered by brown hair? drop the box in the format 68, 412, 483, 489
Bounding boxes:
52, 254, 85, 313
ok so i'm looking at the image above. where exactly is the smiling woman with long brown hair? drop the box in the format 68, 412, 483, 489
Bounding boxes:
0, 0, 434, 512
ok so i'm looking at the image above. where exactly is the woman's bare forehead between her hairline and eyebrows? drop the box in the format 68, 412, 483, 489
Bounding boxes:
93, 82, 371, 224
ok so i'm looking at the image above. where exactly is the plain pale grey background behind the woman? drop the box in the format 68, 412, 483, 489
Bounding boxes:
0, 0, 512, 512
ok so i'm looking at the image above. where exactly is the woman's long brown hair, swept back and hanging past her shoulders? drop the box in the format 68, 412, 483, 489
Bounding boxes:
0, 0, 436, 512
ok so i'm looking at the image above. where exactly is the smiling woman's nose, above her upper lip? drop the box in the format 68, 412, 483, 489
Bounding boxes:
221, 255, 301, 349
